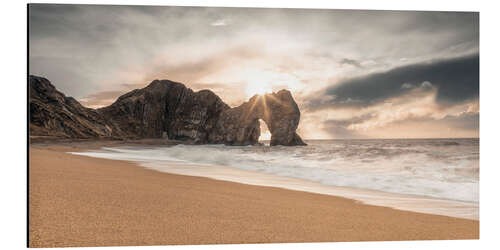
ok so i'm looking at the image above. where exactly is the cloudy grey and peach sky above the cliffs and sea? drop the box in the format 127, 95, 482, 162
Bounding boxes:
29, 4, 479, 139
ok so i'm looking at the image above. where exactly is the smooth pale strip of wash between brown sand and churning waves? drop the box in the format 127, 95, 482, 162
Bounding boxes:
67, 145, 479, 221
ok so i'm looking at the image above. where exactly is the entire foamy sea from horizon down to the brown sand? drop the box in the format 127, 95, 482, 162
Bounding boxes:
73, 138, 479, 220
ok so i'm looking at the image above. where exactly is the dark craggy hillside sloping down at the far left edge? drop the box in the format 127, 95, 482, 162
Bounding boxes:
29, 76, 126, 138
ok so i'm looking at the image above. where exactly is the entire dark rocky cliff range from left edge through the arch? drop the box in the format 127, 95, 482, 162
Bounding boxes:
29, 76, 305, 145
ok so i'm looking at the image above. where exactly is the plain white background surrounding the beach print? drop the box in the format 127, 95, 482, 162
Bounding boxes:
0, 0, 500, 249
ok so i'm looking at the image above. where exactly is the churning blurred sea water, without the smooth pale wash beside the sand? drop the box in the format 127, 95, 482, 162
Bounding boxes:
84, 139, 479, 202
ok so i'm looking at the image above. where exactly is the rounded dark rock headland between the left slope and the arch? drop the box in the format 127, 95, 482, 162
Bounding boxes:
97, 80, 229, 143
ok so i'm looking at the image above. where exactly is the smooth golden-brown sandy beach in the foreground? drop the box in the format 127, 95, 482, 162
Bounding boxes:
29, 145, 479, 247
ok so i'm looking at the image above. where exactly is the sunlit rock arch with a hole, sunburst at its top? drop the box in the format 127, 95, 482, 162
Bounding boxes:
209, 90, 306, 146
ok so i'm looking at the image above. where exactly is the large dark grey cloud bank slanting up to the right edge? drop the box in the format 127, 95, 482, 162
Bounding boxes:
306, 54, 479, 110
